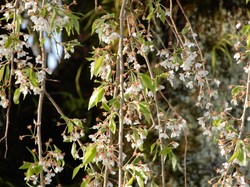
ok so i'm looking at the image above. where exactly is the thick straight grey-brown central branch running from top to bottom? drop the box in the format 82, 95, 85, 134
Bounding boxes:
118, 0, 126, 187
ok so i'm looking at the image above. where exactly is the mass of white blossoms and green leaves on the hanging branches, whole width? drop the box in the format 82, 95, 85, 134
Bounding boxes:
0, 0, 250, 187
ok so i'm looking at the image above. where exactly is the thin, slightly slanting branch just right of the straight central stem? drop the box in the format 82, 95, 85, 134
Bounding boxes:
143, 54, 166, 187
